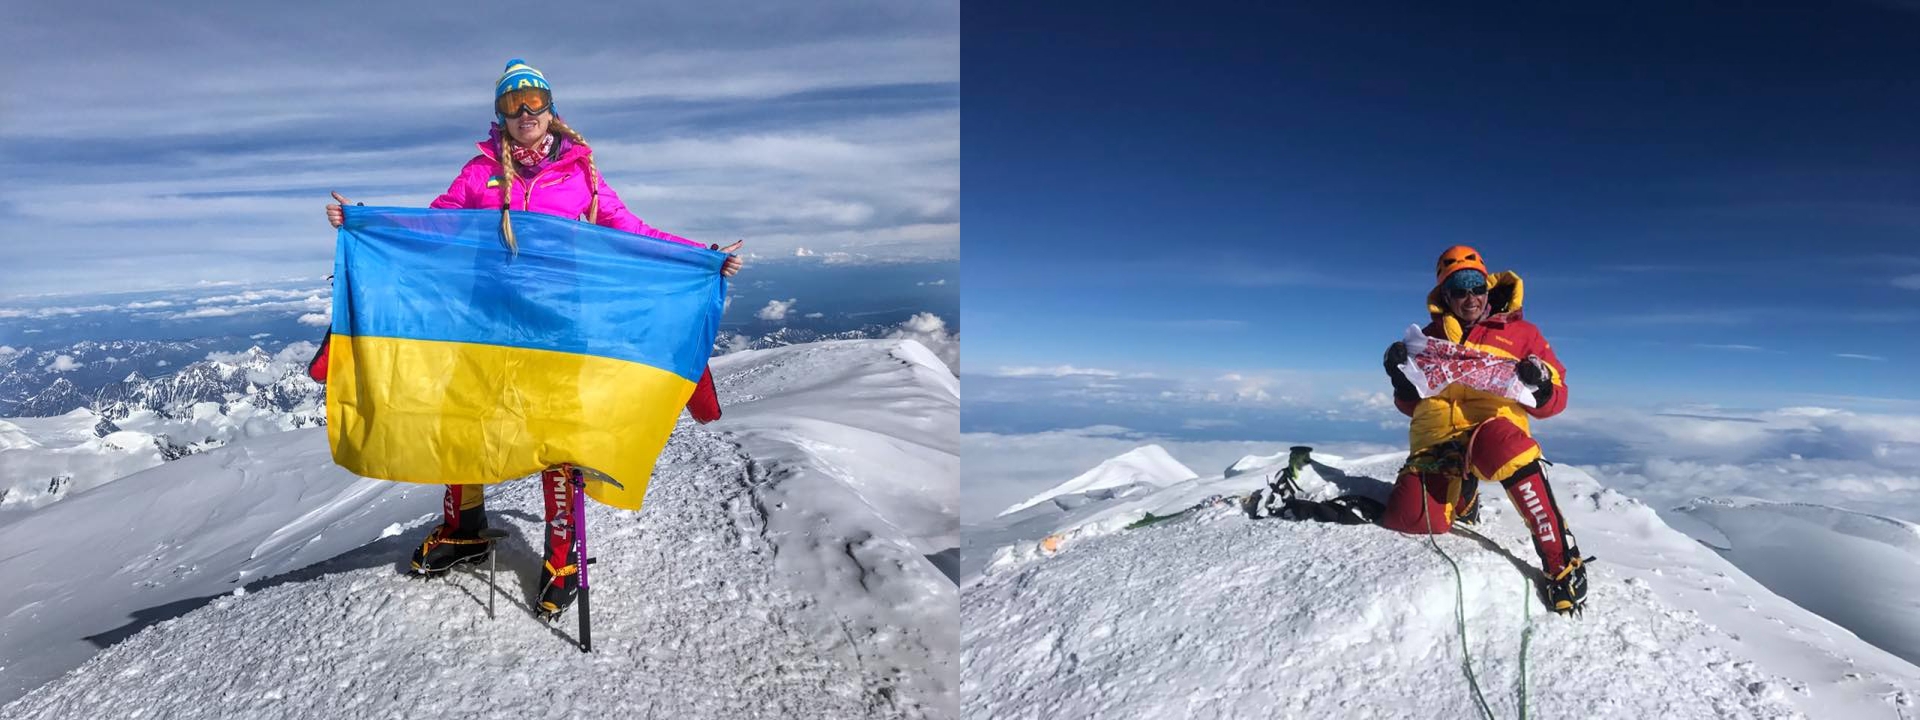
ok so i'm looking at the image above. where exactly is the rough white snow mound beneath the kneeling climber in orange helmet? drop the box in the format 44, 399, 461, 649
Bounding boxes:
960, 453, 1920, 718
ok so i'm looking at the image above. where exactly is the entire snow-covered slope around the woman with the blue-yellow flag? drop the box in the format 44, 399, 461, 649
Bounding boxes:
0, 340, 958, 718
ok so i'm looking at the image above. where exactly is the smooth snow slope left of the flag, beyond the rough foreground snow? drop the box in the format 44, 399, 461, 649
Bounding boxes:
0, 428, 440, 714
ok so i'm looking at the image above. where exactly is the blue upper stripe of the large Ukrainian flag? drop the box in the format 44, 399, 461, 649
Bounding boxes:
334, 205, 726, 382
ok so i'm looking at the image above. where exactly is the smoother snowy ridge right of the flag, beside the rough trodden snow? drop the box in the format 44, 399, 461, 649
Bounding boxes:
712, 340, 960, 716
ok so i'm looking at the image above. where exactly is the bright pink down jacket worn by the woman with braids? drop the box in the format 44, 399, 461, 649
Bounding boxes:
428, 125, 707, 248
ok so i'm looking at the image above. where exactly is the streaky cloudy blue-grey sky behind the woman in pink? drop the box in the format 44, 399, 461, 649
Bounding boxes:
0, 0, 960, 300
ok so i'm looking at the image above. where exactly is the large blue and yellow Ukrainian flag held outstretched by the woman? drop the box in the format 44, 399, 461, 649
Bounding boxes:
326, 205, 726, 509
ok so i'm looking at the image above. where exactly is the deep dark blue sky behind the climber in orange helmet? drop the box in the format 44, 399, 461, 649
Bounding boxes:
962, 2, 1920, 416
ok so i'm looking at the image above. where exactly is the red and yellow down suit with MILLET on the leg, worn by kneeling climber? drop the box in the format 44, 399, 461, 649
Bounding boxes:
1380, 271, 1571, 578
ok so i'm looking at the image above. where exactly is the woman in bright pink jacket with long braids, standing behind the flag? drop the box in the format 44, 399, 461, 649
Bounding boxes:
326, 58, 741, 614
